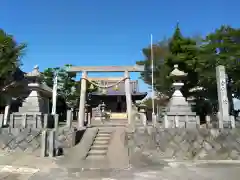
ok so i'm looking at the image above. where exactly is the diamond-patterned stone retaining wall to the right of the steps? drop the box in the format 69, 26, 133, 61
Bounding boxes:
128, 128, 240, 160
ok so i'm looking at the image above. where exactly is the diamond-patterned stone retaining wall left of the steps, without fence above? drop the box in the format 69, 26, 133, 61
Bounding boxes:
0, 127, 82, 156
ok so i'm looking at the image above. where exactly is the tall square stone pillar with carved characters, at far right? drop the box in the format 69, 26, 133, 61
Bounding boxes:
216, 66, 230, 128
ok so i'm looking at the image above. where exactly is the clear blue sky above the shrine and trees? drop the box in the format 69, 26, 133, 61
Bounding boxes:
0, 0, 240, 93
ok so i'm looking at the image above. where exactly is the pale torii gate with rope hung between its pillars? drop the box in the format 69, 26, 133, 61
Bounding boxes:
68, 65, 144, 129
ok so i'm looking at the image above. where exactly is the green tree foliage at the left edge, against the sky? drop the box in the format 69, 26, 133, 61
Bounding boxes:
0, 29, 26, 92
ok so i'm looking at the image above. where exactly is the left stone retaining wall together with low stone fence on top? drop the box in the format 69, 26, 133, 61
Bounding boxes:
0, 111, 84, 157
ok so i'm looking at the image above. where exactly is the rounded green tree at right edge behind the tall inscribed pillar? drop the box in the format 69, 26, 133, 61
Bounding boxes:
199, 26, 240, 113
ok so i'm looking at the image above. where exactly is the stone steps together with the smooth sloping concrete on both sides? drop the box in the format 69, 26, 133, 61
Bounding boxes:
57, 126, 129, 169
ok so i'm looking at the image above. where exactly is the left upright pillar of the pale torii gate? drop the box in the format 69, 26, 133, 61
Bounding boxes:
78, 71, 87, 129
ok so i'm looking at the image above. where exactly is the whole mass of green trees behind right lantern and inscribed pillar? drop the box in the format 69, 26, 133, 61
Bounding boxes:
137, 25, 240, 112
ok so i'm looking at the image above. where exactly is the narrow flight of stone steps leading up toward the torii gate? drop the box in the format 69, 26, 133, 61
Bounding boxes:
86, 129, 112, 160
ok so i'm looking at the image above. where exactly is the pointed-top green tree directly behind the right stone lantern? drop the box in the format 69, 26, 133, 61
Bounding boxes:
137, 25, 201, 96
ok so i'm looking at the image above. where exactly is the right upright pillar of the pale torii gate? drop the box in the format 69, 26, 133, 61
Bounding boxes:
124, 71, 132, 125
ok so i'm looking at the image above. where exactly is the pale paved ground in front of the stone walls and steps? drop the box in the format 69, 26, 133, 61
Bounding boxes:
0, 151, 240, 180
